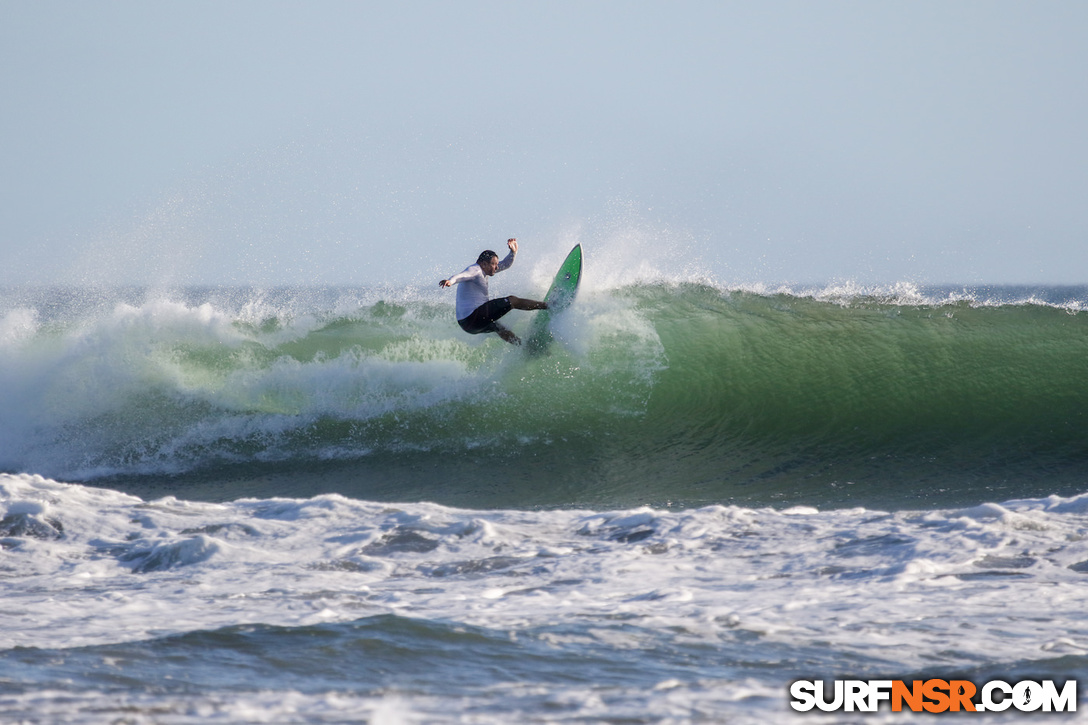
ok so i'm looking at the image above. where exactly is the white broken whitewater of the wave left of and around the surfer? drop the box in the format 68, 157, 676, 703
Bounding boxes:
0, 283, 678, 480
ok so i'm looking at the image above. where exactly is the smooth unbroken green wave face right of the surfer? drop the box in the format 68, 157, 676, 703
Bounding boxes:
617, 287, 1088, 503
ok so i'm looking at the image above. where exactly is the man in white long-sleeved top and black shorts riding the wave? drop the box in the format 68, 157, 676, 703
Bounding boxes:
438, 239, 547, 345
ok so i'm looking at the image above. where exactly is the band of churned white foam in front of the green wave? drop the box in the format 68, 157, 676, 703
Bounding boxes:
0, 476, 1088, 668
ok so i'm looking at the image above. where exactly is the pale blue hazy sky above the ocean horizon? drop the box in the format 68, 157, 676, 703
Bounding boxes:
0, 0, 1088, 284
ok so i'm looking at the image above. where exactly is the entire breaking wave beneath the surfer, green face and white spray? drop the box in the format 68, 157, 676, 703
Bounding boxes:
0, 284, 1088, 507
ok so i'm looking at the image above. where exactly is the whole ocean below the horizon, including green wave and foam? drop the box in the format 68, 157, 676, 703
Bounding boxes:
0, 278, 1088, 723
